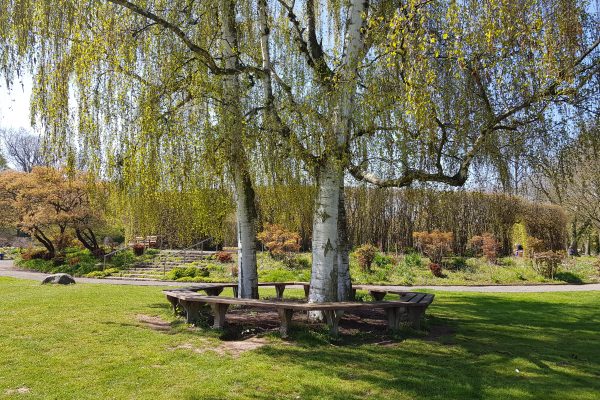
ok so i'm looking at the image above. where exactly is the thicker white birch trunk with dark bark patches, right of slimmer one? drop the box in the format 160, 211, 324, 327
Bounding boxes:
309, 0, 369, 304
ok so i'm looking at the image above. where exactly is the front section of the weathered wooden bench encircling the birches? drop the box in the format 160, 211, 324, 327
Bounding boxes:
163, 289, 434, 337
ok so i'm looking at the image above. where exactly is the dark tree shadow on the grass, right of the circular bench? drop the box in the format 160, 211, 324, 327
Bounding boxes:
241, 294, 600, 399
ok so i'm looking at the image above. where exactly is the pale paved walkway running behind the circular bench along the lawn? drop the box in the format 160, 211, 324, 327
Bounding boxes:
0, 261, 600, 293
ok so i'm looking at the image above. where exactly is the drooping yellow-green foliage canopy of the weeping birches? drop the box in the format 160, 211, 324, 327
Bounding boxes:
0, 0, 598, 247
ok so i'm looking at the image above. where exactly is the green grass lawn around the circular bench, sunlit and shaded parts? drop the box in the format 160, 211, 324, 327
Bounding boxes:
0, 278, 600, 400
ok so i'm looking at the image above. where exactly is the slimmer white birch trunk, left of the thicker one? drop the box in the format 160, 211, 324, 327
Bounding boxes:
219, 0, 258, 298
